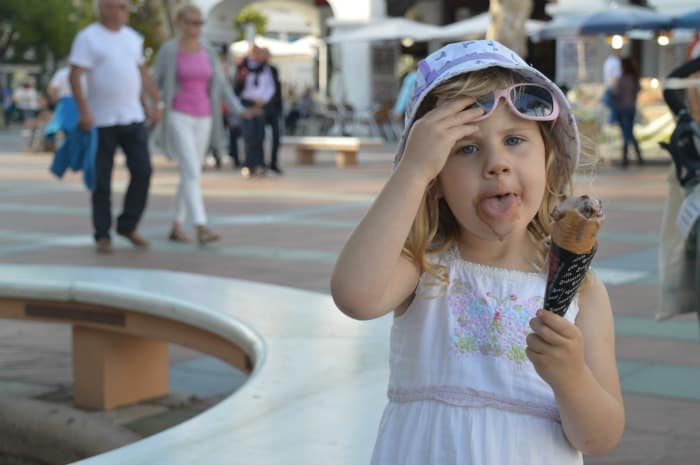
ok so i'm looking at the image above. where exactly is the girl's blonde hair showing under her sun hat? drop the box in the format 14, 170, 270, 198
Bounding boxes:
403, 67, 573, 285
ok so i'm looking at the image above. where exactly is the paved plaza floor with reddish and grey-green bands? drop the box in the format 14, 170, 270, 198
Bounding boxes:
0, 125, 700, 465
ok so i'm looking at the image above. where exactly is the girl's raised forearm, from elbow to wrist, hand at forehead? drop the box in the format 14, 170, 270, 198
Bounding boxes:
331, 169, 426, 313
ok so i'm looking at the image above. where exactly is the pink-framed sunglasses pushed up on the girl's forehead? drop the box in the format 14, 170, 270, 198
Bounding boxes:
469, 84, 559, 125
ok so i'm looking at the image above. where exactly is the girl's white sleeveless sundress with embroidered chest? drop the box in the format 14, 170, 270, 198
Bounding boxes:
372, 248, 583, 465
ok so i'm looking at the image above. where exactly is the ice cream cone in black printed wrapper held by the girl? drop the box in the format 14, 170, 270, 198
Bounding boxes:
544, 196, 603, 316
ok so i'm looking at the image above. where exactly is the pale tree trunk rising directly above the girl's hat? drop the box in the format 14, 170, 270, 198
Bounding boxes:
486, 0, 533, 58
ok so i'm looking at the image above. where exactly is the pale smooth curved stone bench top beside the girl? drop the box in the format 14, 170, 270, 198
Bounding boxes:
0, 265, 391, 465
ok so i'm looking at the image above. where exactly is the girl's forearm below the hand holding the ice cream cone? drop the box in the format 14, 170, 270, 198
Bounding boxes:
554, 369, 625, 455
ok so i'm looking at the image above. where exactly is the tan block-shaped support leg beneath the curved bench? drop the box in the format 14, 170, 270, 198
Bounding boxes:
73, 325, 169, 410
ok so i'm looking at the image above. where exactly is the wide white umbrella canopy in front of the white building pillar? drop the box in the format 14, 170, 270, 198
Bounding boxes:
325, 18, 440, 44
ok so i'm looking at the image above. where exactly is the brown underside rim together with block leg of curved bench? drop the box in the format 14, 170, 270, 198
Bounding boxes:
0, 297, 253, 410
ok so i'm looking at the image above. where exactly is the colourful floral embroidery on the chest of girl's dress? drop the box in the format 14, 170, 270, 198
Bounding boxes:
447, 281, 542, 365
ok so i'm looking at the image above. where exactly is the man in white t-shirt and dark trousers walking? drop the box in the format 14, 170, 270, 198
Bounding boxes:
69, 0, 163, 253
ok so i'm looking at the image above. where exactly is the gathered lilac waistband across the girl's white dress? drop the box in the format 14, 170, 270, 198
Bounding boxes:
388, 386, 561, 423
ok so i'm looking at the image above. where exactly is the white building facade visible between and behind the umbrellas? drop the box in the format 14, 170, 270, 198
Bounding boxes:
196, 0, 697, 109
